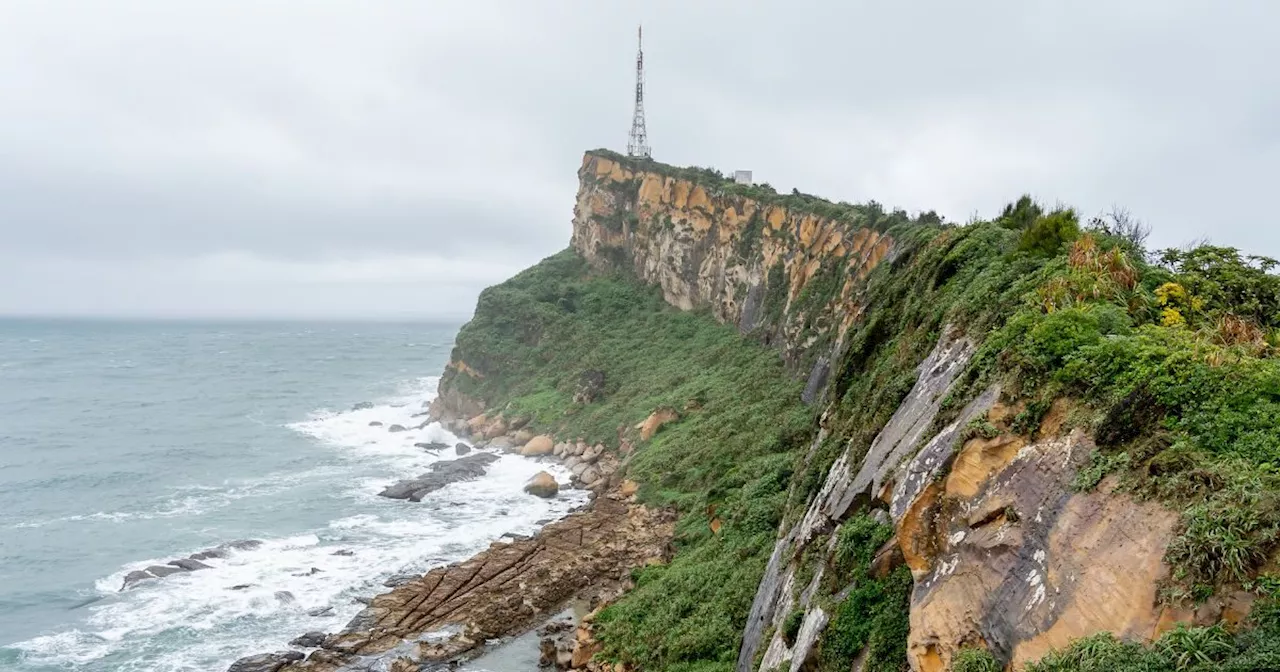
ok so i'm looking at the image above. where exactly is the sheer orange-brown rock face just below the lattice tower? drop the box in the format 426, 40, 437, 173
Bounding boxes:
572, 152, 893, 394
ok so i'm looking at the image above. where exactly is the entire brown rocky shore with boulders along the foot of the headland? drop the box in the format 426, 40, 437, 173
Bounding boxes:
228, 403, 675, 672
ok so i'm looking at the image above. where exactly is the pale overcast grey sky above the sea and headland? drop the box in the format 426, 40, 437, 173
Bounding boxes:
0, 0, 1280, 320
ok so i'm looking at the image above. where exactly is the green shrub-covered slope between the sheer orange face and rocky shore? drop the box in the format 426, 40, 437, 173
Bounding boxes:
451, 252, 812, 669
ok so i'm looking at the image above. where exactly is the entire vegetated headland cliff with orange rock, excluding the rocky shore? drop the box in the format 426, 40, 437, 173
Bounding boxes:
285, 151, 1280, 672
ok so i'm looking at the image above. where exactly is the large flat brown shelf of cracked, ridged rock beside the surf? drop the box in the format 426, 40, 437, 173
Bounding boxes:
264, 494, 675, 671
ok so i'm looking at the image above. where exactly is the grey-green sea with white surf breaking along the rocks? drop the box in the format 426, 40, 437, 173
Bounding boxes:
0, 320, 586, 672
